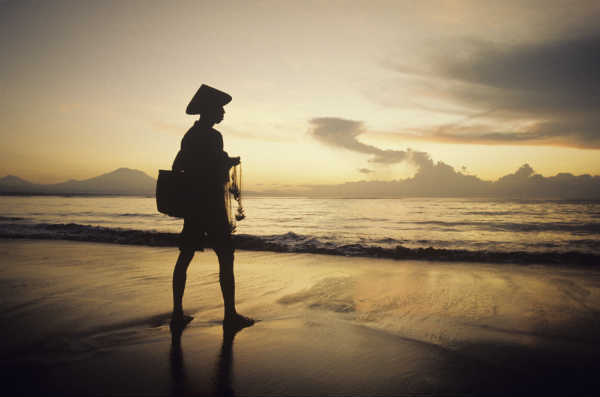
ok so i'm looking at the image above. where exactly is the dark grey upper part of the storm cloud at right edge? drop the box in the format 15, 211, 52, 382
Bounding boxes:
439, 36, 600, 108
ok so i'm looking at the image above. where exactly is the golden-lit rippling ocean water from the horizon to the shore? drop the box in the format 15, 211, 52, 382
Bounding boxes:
0, 196, 600, 260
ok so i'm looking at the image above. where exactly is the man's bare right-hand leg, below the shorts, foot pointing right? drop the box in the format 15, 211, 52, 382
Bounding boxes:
215, 248, 254, 329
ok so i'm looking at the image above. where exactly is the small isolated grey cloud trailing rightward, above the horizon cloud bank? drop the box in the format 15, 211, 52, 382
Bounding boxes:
310, 117, 431, 166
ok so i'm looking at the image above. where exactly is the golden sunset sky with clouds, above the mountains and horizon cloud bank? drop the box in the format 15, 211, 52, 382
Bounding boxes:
0, 0, 600, 190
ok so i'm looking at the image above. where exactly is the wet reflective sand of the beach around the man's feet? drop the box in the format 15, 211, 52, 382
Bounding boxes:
0, 240, 600, 395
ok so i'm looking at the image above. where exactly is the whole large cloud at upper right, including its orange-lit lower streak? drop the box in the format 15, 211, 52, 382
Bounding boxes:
386, 34, 600, 149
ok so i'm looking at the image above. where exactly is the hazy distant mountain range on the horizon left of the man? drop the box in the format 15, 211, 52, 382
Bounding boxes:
0, 168, 156, 196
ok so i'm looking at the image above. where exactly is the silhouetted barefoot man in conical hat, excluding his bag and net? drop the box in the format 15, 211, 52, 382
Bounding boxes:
171, 85, 254, 329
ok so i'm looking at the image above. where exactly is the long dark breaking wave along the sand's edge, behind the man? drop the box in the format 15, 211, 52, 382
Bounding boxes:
0, 223, 600, 265
